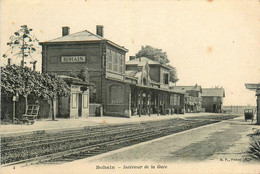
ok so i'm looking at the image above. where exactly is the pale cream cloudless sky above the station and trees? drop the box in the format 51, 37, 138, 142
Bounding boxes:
1, 0, 260, 105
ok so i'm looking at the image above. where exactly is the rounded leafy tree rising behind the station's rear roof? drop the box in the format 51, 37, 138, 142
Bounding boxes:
135, 45, 179, 83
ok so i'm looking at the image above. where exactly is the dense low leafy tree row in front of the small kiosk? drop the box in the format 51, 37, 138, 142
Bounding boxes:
1, 65, 69, 120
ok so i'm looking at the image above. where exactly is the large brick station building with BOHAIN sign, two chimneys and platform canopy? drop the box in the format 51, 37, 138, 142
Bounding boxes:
40, 25, 184, 117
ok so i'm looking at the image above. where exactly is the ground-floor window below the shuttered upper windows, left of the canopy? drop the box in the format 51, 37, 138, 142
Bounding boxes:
109, 85, 124, 104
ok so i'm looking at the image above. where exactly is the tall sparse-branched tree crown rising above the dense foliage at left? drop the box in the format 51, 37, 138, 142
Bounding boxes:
3, 25, 39, 67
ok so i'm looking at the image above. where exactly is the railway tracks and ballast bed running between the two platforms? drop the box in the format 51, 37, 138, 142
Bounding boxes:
1, 115, 239, 166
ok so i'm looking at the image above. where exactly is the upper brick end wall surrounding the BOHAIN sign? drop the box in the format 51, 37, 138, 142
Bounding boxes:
42, 44, 102, 74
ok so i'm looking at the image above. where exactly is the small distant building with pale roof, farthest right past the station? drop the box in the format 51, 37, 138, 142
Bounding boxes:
202, 88, 225, 113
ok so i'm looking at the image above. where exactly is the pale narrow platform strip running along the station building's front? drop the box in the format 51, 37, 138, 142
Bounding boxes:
1, 113, 236, 137
